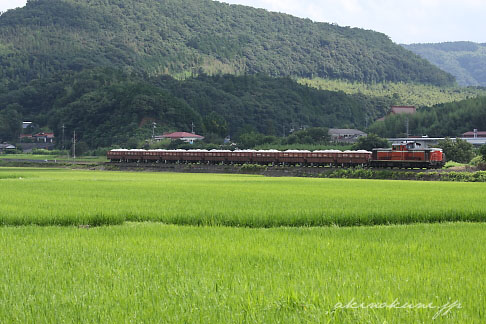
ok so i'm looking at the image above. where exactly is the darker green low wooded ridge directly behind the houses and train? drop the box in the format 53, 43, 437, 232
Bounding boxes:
0, 69, 390, 148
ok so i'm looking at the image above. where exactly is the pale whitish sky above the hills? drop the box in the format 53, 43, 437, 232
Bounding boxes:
0, 0, 486, 44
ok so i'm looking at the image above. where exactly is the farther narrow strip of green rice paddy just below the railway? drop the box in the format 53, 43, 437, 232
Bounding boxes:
0, 168, 486, 227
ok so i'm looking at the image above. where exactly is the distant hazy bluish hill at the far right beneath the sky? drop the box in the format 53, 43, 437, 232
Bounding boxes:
403, 42, 486, 87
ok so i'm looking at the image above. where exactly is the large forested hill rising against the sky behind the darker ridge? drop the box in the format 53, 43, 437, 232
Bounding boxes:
0, 0, 454, 87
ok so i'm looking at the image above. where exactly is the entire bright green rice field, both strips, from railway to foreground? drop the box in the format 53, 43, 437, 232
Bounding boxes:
0, 168, 486, 324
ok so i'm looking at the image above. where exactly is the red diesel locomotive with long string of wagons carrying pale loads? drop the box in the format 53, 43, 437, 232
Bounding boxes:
107, 142, 445, 168
